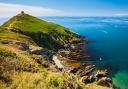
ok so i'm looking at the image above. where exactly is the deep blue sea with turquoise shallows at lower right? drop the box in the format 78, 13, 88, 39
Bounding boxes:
0, 17, 128, 89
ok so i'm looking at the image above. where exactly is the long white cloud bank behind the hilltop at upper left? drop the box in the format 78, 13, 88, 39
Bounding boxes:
0, 3, 63, 17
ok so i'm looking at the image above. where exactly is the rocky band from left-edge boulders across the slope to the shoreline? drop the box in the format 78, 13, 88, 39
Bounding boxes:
0, 32, 114, 89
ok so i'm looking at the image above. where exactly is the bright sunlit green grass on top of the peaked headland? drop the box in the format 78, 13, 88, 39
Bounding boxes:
2, 14, 72, 34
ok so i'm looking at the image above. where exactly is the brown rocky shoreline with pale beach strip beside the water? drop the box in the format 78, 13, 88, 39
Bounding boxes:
53, 36, 116, 89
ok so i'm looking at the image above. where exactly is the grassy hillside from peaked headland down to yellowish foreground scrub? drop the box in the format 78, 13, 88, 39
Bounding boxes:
0, 13, 84, 89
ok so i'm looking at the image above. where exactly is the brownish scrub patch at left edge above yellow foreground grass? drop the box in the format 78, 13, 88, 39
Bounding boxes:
0, 57, 38, 74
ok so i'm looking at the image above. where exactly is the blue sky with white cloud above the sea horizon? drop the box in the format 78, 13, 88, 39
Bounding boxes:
0, 0, 128, 17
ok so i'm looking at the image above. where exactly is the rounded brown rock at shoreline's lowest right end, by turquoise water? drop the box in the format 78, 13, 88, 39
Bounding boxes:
97, 77, 112, 87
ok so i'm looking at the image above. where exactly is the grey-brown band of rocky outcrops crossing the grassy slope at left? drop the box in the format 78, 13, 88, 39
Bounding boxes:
0, 40, 54, 59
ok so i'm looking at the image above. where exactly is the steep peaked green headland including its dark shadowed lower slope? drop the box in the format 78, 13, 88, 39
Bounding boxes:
2, 13, 79, 49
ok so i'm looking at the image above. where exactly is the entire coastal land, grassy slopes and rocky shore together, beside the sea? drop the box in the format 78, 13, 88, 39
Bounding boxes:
0, 12, 113, 89
